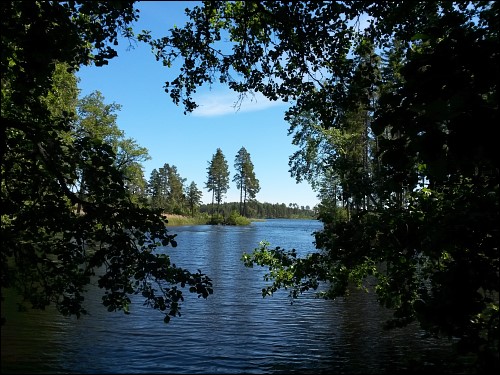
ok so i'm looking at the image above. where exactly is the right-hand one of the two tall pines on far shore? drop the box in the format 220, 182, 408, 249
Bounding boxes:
233, 147, 260, 216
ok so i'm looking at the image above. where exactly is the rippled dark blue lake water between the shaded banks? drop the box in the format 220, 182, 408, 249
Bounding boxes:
1, 219, 464, 374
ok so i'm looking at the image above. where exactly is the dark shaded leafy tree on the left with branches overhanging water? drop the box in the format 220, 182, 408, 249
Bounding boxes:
0, 1, 212, 322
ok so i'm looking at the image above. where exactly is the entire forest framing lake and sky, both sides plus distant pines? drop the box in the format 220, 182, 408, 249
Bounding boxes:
0, 1, 500, 373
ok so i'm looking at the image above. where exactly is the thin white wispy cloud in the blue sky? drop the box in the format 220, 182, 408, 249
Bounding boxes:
192, 92, 286, 117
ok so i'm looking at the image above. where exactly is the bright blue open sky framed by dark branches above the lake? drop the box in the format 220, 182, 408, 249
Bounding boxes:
77, 1, 319, 208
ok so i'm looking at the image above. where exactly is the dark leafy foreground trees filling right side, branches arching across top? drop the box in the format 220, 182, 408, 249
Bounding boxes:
141, 1, 500, 371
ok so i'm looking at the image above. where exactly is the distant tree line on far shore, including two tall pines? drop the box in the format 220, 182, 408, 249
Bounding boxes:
146, 147, 315, 218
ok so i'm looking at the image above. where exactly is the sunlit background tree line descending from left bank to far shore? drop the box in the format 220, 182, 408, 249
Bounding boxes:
36, 64, 311, 223
